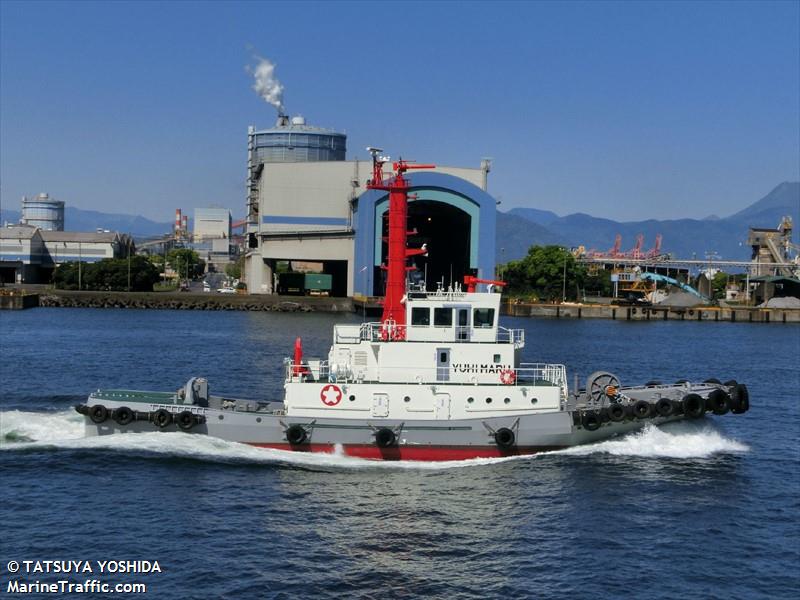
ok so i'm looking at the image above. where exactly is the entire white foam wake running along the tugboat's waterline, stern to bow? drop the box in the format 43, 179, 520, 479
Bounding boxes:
0, 410, 749, 470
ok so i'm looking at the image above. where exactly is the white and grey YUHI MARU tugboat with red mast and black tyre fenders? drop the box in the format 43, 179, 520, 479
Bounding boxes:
75, 150, 750, 461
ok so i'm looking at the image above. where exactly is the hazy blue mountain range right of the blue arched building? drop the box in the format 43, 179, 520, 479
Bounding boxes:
497, 182, 800, 262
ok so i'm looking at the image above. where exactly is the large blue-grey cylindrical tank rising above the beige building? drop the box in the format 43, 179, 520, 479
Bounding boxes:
249, 116, 347, 164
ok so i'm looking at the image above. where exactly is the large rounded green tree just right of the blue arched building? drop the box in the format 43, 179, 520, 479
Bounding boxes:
503, 246, 587, 301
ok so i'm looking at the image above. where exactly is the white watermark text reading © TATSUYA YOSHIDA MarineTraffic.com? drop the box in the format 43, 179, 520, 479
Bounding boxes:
3, 560, 162, 594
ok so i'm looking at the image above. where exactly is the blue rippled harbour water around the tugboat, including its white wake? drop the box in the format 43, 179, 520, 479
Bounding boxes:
0, 309, 800, 599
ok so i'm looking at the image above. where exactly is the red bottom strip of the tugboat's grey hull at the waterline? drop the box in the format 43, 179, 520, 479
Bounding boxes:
250, 443, 560, 461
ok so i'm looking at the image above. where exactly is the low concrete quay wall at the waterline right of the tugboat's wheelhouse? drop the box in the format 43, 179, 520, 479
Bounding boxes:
501, 303, 800, 323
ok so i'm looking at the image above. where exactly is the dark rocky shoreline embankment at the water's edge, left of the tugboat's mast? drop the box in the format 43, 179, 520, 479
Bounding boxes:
34, 290, 353, 312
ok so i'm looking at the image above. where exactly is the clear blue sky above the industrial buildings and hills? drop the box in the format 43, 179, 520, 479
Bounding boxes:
0, 0, 800, 221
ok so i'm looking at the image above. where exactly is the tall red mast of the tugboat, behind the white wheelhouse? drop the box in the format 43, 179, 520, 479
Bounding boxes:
367, 148, 436, 340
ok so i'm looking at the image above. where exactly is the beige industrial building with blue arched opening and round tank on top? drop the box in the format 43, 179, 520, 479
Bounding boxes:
245, 116, 496, 296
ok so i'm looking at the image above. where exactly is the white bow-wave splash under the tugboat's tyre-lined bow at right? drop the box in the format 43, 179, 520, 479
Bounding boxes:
548, 421, 750, 458
